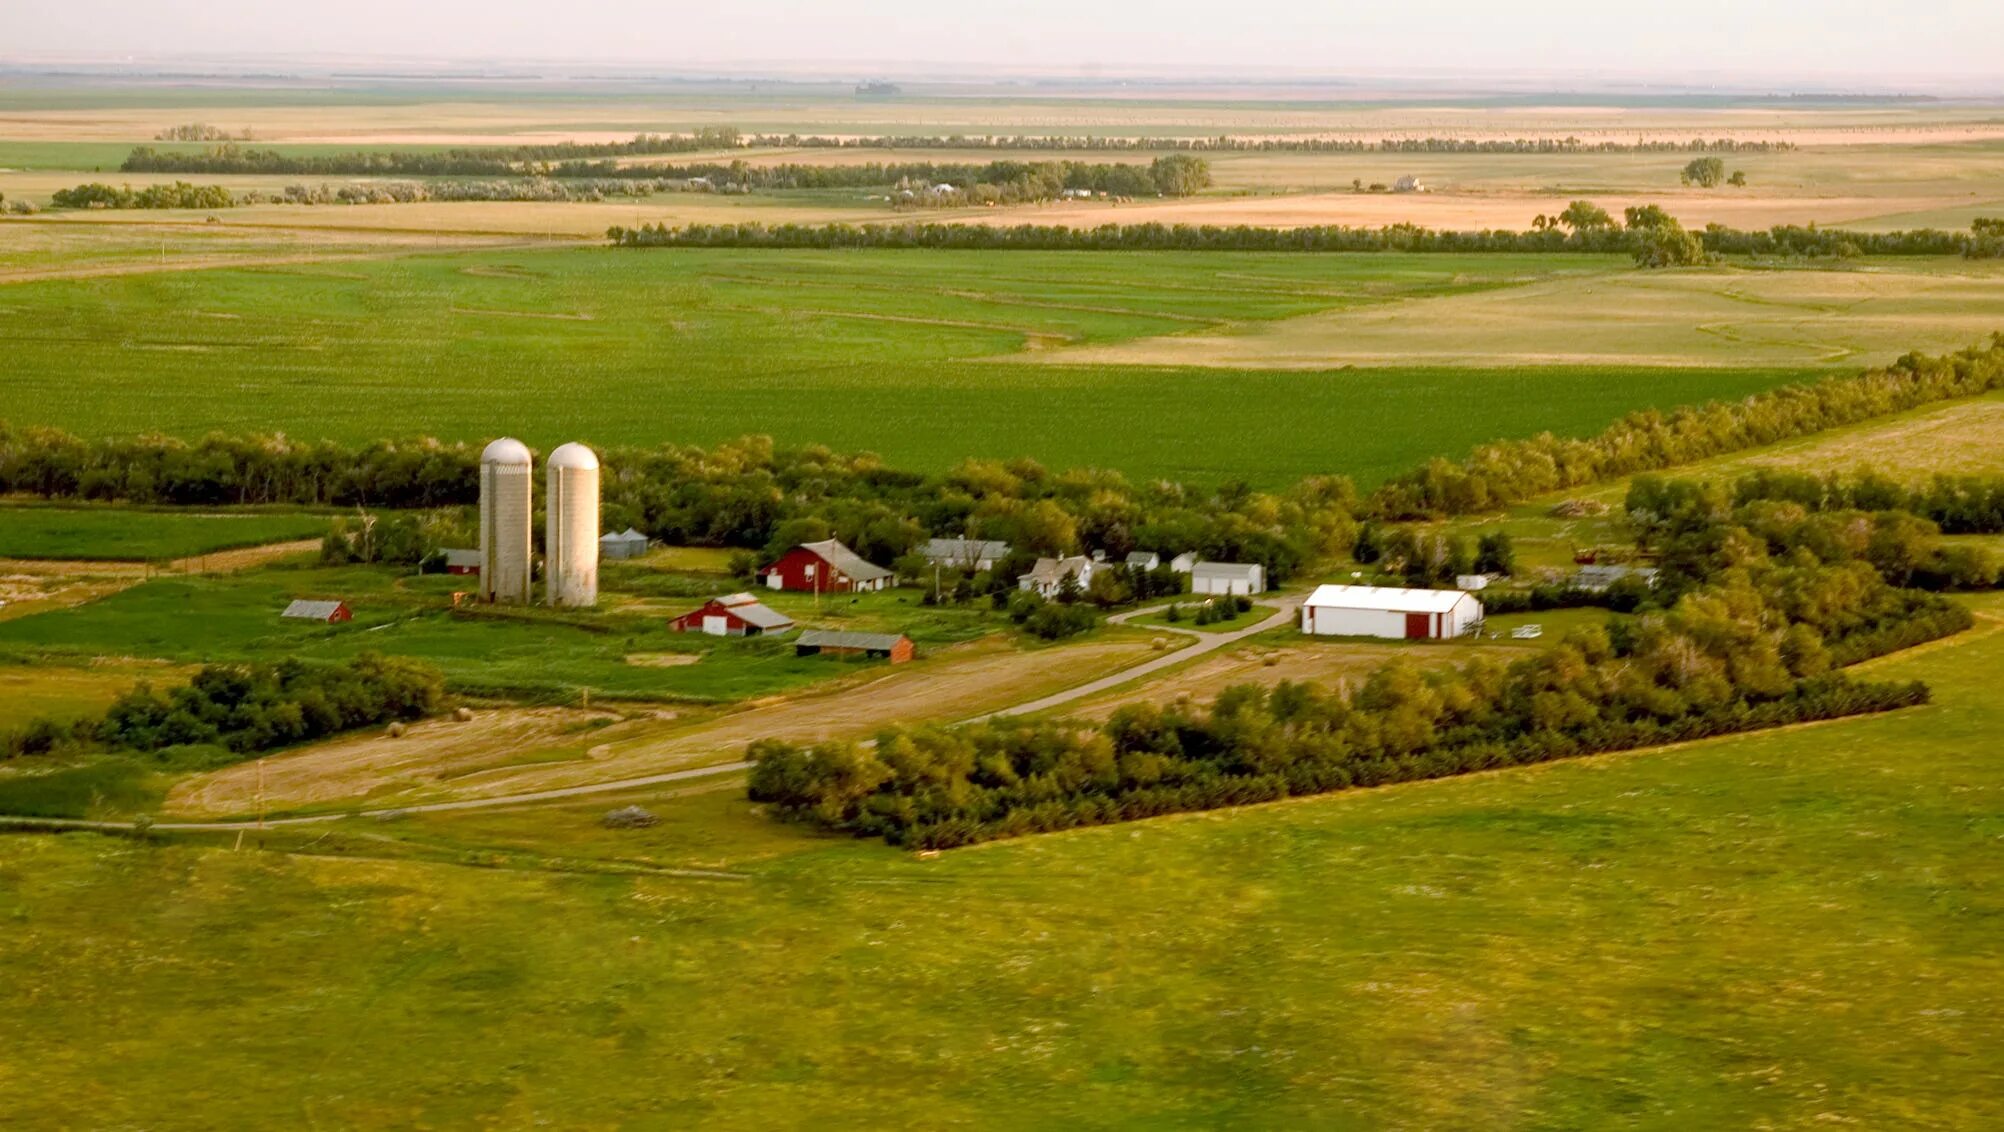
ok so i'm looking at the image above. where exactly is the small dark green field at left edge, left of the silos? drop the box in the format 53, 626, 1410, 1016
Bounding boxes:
0, 507, 327, 561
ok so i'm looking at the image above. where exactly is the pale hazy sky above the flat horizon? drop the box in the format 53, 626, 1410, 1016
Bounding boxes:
15, 0, 2004, 86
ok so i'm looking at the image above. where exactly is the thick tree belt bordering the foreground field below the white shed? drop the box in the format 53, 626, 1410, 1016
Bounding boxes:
749, 567, 1939, 847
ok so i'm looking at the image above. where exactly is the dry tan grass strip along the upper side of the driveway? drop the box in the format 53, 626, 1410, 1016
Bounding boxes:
166, 635, 1156, 815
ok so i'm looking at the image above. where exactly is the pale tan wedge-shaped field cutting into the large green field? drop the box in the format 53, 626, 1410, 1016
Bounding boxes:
1042, 262, 2004, 369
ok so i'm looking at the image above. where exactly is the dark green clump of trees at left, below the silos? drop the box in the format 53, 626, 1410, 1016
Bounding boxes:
0, 655, 445, 755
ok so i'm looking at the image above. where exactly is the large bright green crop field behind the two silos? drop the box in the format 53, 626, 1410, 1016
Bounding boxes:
0, 248, 1804, 485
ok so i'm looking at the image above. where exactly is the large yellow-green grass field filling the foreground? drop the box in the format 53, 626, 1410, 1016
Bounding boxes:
0, 601, 2004, 1128
